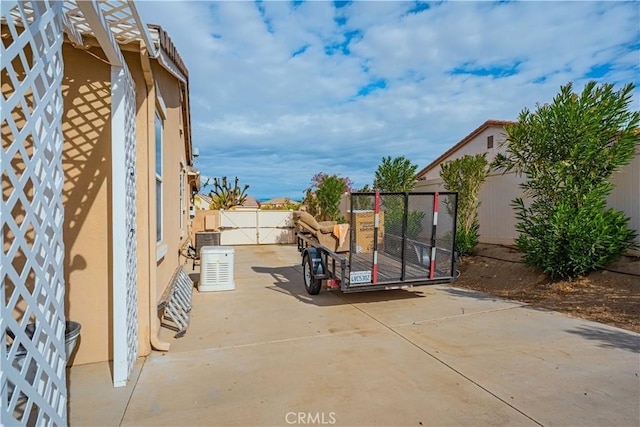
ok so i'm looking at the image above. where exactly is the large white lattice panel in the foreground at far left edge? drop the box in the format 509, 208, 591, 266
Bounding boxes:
0, 0, 67, 426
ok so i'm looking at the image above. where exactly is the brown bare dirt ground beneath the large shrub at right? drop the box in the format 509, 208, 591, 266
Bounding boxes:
452, 244, 640, 333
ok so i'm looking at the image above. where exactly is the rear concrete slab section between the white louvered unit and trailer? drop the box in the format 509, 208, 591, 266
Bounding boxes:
161, 246, 380, 352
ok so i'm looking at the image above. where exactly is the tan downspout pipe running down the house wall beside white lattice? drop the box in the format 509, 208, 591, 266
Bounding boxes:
140, 48, 171, 351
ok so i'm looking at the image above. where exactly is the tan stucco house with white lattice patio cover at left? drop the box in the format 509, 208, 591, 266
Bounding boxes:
0, 0, 199, 425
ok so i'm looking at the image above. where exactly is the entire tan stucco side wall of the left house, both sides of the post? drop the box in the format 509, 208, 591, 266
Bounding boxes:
63, 44, 190, 364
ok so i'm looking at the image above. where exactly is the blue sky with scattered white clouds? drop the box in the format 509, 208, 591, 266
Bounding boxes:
136, 0, 640, 200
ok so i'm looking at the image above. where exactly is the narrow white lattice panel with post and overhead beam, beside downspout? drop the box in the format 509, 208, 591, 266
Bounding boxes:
72, 1, 138, 387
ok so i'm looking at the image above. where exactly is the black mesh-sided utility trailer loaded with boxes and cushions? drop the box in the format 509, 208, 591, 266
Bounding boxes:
296, 192, 457, 295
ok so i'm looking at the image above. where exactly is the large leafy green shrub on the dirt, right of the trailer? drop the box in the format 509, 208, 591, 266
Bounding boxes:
495, 82, 640, 278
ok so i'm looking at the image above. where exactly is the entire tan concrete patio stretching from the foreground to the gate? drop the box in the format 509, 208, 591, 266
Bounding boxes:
68, 246, 640, 426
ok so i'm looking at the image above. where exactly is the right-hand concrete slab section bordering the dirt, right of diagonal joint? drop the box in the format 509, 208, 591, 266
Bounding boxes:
394, 289, 640, 426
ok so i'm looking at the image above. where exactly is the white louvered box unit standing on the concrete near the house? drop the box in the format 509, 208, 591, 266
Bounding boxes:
198, 246, 236, 292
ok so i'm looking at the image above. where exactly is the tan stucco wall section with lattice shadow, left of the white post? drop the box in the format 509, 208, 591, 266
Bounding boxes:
62, 44, 112, 364
